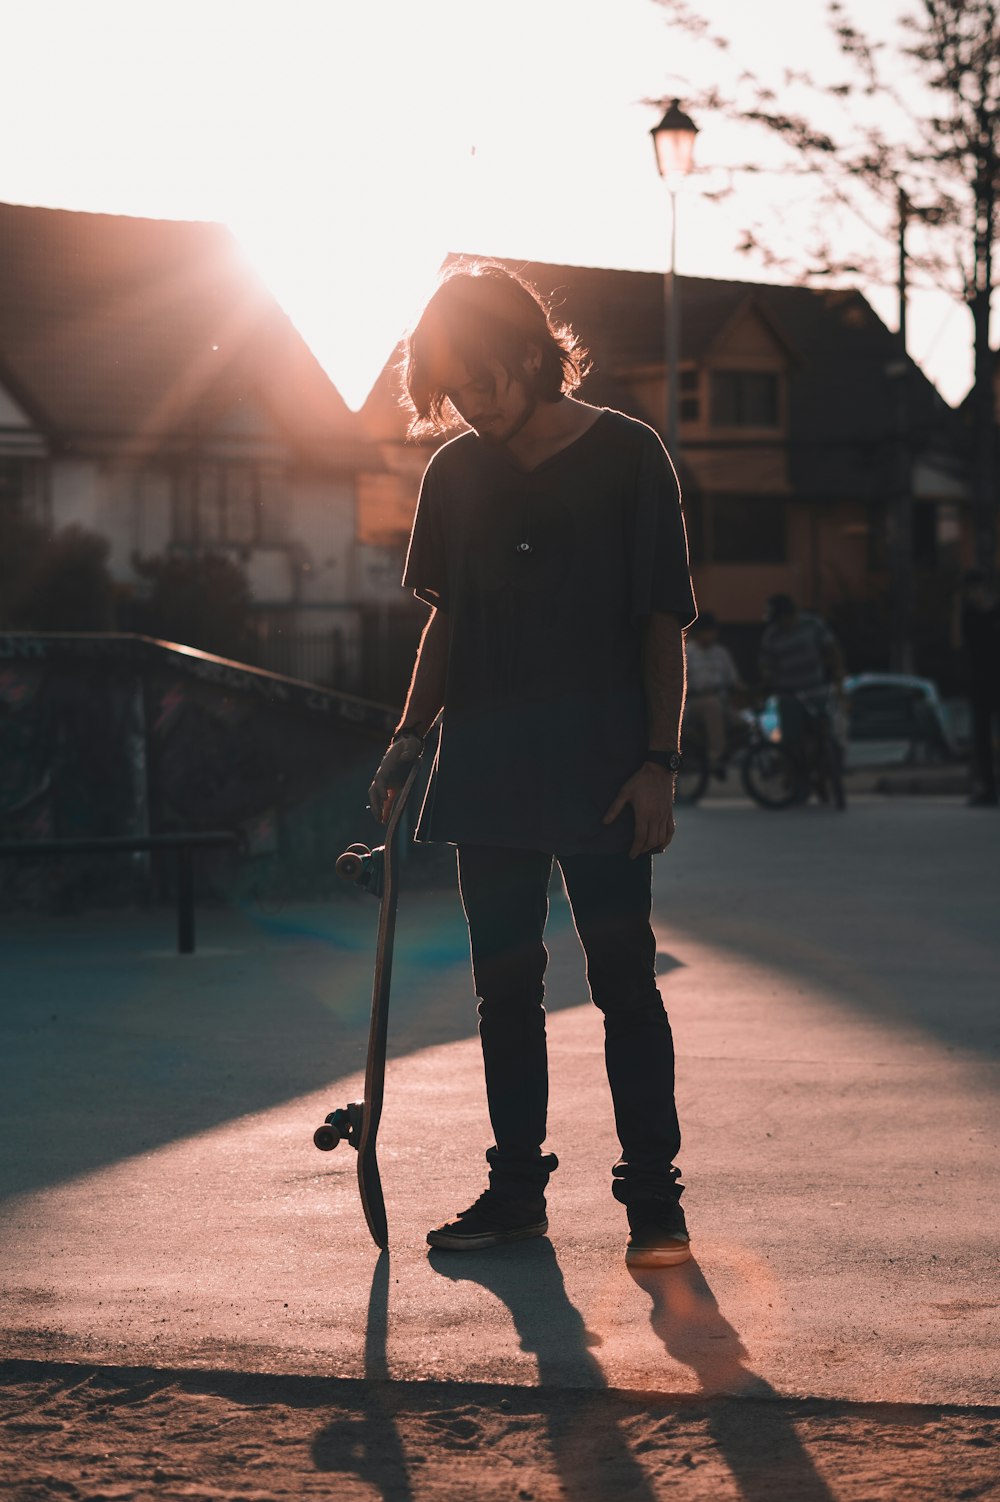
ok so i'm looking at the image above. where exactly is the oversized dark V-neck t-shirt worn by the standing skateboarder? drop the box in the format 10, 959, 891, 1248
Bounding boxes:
402, 410, 695, 855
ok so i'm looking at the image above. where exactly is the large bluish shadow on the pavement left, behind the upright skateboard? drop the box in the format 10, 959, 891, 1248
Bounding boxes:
0, 882, 587, 1199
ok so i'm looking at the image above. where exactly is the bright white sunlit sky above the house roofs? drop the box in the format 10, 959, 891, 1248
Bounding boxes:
0, 0, 971, 407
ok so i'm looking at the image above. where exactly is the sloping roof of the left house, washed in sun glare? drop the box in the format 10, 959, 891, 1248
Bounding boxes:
0, 204, 369, 463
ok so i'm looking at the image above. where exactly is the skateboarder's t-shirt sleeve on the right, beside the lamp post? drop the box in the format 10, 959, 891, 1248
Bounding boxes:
632, 428, 698, 626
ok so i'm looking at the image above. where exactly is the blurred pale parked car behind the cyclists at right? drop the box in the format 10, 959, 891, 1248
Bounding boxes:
761, 673, 961, 771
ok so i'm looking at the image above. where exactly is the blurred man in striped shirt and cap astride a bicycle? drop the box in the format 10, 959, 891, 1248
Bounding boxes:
760, 595, 844, 796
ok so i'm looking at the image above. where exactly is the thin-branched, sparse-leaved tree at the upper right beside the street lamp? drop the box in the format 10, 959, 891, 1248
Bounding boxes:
656, 0, 1000, 572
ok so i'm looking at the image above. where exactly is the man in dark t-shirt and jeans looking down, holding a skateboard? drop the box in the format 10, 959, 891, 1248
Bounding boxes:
371, 264, 695, 1266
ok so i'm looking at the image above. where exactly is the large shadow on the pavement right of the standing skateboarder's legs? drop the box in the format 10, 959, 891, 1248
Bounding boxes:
653, 801, 1000, 1060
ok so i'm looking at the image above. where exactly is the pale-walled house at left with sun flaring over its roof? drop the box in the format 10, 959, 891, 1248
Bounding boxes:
0, 204, 422, 683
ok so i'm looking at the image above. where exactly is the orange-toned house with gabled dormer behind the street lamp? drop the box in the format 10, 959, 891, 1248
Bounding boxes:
465, 263, 968, 665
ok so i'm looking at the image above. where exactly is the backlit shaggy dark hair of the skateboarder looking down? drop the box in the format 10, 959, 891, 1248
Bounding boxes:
399, 261, 590, 439
